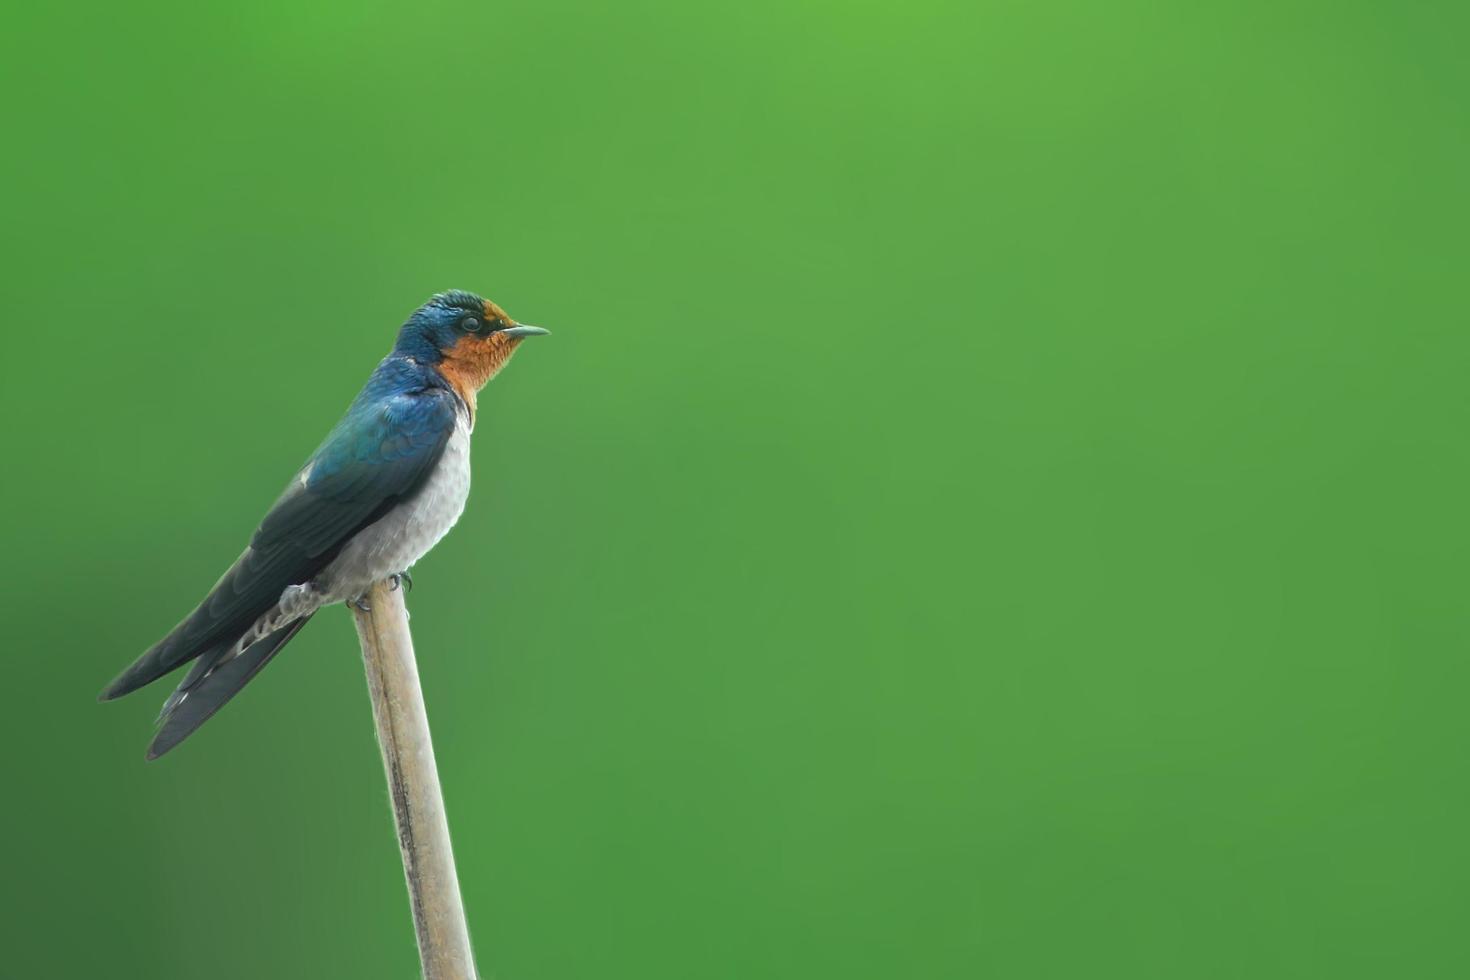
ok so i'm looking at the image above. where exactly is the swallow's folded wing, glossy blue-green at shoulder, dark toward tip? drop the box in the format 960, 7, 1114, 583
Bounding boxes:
101, 388, 457, 701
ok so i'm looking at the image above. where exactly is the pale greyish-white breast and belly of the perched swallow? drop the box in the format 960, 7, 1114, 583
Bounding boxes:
320, 416, 469, 601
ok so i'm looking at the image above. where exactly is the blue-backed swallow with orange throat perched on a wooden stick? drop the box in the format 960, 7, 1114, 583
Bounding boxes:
98, 289, 550, 760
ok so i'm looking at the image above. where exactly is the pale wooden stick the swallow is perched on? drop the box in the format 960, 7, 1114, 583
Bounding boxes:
353, 582, 478, 980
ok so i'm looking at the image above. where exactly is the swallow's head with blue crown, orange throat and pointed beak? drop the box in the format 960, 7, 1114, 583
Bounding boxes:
394, 289, 548, 411
